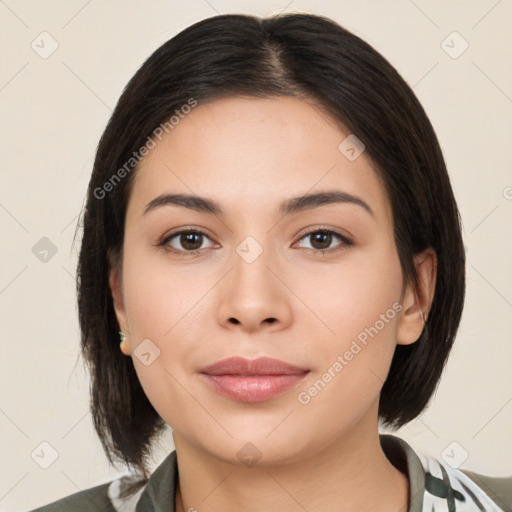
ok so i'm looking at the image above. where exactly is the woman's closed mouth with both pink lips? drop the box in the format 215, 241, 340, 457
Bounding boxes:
200, 357, 310, 403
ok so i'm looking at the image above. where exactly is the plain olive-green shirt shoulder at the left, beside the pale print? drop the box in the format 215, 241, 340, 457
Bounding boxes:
30, 482, 116, 512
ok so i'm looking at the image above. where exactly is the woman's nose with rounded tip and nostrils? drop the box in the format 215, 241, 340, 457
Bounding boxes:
218, 241, 292, 333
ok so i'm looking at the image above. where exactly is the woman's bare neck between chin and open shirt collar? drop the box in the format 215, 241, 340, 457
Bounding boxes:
173, 414, 410, 512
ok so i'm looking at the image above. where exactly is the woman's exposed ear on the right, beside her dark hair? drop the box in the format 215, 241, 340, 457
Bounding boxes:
397, 247, 437, 345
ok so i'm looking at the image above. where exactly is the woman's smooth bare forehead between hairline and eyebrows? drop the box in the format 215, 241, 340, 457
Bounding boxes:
130, 97, 390, 223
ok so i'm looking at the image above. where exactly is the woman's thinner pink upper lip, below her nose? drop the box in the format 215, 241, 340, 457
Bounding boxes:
201, 357, 309, 375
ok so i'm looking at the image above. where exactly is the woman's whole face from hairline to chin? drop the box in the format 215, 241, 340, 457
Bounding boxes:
111, 94, 428, 464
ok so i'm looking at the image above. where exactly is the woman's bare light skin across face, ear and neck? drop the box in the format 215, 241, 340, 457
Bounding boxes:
110, 97, 436, 512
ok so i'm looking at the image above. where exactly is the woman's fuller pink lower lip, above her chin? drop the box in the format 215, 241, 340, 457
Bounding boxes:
203, 373, 307, 403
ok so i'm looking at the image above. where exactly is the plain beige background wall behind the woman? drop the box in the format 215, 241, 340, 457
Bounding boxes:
0, 0, 512, 511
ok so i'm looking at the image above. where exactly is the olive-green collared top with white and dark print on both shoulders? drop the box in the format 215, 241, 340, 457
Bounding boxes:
32, 434, 512, 512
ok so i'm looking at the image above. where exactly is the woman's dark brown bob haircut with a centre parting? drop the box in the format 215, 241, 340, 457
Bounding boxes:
77, 13, 465, 496
